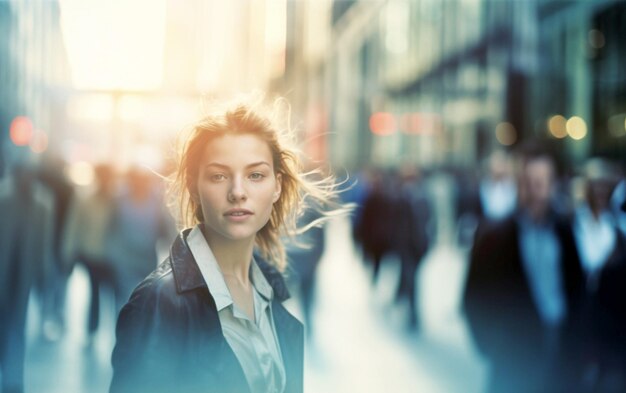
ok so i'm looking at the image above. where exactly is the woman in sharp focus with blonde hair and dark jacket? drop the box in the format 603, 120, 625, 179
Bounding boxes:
111, 95, 334, 393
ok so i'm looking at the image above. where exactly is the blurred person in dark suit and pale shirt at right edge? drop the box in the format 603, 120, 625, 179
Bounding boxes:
573, 158, 624, 391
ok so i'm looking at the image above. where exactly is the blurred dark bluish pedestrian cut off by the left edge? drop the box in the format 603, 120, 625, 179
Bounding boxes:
0, 163, 52, 393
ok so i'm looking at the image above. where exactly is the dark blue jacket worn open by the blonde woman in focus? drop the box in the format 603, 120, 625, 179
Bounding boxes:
110, 229, 304, 393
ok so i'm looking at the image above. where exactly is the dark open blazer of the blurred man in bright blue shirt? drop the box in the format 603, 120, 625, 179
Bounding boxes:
463, 211, 584, 361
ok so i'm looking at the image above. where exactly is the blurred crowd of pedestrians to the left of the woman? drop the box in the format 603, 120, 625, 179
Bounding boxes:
0, 155, 175, 393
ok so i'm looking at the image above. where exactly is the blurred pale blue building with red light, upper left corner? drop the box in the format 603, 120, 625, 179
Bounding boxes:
0, 1, 69, 175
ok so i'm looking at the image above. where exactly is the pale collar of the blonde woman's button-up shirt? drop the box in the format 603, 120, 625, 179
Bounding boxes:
187, 225, 273, 312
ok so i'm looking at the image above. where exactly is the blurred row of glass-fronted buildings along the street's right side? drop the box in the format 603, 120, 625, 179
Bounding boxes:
286, 0, 626, 172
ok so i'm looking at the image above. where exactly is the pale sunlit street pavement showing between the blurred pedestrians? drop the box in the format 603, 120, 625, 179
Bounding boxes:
19, 175, 487, 393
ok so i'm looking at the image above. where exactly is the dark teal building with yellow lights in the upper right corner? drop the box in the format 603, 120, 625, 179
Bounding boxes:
530, 0, 626, 164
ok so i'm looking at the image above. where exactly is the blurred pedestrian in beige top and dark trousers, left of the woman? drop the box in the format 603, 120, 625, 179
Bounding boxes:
64, 164, 120, 343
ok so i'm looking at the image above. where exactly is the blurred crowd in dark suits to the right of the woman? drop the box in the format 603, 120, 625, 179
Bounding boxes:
346, 142, 626, 392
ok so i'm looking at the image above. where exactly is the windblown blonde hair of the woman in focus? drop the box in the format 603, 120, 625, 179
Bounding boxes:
170, 95, 348, 271
